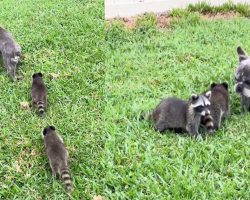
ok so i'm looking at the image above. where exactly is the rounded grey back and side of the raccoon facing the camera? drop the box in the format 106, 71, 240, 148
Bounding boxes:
152, 97, 188, 128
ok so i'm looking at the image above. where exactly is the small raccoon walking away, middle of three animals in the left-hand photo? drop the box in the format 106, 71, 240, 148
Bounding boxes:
31, 72, 47, 116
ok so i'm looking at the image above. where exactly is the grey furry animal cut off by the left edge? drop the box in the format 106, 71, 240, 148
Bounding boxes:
0, 27, 21, 80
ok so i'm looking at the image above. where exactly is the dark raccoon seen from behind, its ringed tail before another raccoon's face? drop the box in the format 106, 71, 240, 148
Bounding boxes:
202, 82, 229, 133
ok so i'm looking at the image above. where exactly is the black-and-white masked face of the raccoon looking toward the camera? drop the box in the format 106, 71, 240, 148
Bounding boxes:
191, 93, 211, 116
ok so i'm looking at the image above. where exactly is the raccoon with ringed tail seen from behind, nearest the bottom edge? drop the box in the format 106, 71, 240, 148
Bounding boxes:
43, 126, 72, 192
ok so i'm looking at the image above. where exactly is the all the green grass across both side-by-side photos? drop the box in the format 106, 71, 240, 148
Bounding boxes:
0, 0, 250, 200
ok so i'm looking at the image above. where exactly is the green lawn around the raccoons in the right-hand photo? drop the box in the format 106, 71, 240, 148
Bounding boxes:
105, 9, 250, 200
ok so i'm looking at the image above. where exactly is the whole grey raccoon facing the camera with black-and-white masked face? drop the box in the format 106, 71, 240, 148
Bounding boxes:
149, 94, 210, 136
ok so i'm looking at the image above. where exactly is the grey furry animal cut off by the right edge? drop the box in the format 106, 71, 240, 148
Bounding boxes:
235, 47, 250, 112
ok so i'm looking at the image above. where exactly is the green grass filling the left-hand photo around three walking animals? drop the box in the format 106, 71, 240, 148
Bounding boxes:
0, 0, 104, 199
